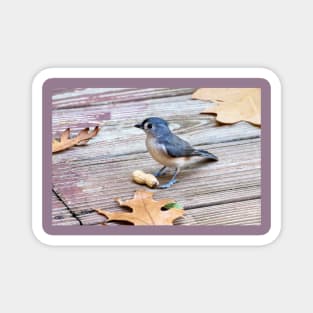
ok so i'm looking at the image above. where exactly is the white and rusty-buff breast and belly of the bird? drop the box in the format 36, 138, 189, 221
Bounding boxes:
146, 135, 186, 168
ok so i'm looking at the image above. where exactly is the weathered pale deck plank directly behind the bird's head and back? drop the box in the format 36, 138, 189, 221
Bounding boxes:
53, 97, 261, 162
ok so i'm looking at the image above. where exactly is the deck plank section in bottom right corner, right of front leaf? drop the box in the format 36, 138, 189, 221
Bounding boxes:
174, 199, 261, 225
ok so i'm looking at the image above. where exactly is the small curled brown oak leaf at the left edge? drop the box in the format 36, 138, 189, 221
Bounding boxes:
52, 126, 100, 152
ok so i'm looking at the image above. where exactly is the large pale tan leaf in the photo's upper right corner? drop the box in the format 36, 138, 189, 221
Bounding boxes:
192, 88, 261, 126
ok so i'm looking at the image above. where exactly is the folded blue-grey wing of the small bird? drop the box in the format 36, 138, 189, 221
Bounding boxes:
160, 134, 195, 158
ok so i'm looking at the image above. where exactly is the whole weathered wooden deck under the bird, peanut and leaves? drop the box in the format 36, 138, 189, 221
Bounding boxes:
52, 88, 261, 226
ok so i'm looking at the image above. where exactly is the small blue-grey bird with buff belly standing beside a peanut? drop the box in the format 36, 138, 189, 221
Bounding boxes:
134, 117, 218, 189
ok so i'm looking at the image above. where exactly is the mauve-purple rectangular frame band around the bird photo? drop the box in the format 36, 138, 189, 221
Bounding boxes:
42, 78, 271, 235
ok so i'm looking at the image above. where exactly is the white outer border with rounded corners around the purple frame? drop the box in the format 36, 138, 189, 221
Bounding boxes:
32, 68, 281, 246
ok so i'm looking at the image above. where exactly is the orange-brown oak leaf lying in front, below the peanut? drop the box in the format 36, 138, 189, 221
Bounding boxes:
96, 189, 184, 225
